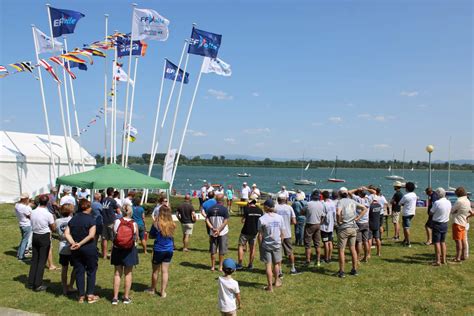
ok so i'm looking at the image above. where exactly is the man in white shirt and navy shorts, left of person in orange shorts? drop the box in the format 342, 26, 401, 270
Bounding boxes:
430, 188, 451, 266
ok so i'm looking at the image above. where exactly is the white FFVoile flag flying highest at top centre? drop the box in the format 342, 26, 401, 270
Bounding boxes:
132, 9, 170, 41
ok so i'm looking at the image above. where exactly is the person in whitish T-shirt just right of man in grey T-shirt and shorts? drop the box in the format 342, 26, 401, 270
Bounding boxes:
275, 194, 298, 275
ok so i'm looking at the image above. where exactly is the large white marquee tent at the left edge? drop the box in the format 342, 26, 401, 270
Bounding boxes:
0, 131, 96, 203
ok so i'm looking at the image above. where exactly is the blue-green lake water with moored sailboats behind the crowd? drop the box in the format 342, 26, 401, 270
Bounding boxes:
131, 165, 474, 195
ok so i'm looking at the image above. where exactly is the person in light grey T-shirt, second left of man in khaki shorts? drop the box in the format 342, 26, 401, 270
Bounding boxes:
303, 190, 326, 267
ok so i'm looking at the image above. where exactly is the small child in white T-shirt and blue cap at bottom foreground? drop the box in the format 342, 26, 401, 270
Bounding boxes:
217, 258, 242, 316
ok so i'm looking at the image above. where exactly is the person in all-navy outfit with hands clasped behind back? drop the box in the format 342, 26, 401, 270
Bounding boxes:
64, 200, 99, 304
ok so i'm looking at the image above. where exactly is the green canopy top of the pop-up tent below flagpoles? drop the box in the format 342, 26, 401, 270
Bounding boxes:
56, 164, 170, 190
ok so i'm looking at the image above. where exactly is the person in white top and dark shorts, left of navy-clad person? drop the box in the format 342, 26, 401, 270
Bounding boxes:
56, 203, 76, 295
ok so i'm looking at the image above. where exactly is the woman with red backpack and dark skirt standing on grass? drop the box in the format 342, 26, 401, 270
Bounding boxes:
110, 205, 138, 305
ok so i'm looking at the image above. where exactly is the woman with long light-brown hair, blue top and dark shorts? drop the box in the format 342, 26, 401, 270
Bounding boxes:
146, 205, 176, 298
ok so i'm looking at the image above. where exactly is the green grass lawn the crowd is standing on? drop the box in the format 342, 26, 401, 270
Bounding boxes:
0, 201, 474, 315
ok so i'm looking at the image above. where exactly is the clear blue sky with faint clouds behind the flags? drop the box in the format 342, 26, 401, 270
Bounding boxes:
0, 0, 474, 161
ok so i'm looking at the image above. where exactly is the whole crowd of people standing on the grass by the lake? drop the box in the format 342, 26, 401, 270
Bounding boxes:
15, 182, 474, 314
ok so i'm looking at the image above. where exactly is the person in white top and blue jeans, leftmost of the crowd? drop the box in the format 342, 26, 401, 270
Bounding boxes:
15, 193, 32, 261
